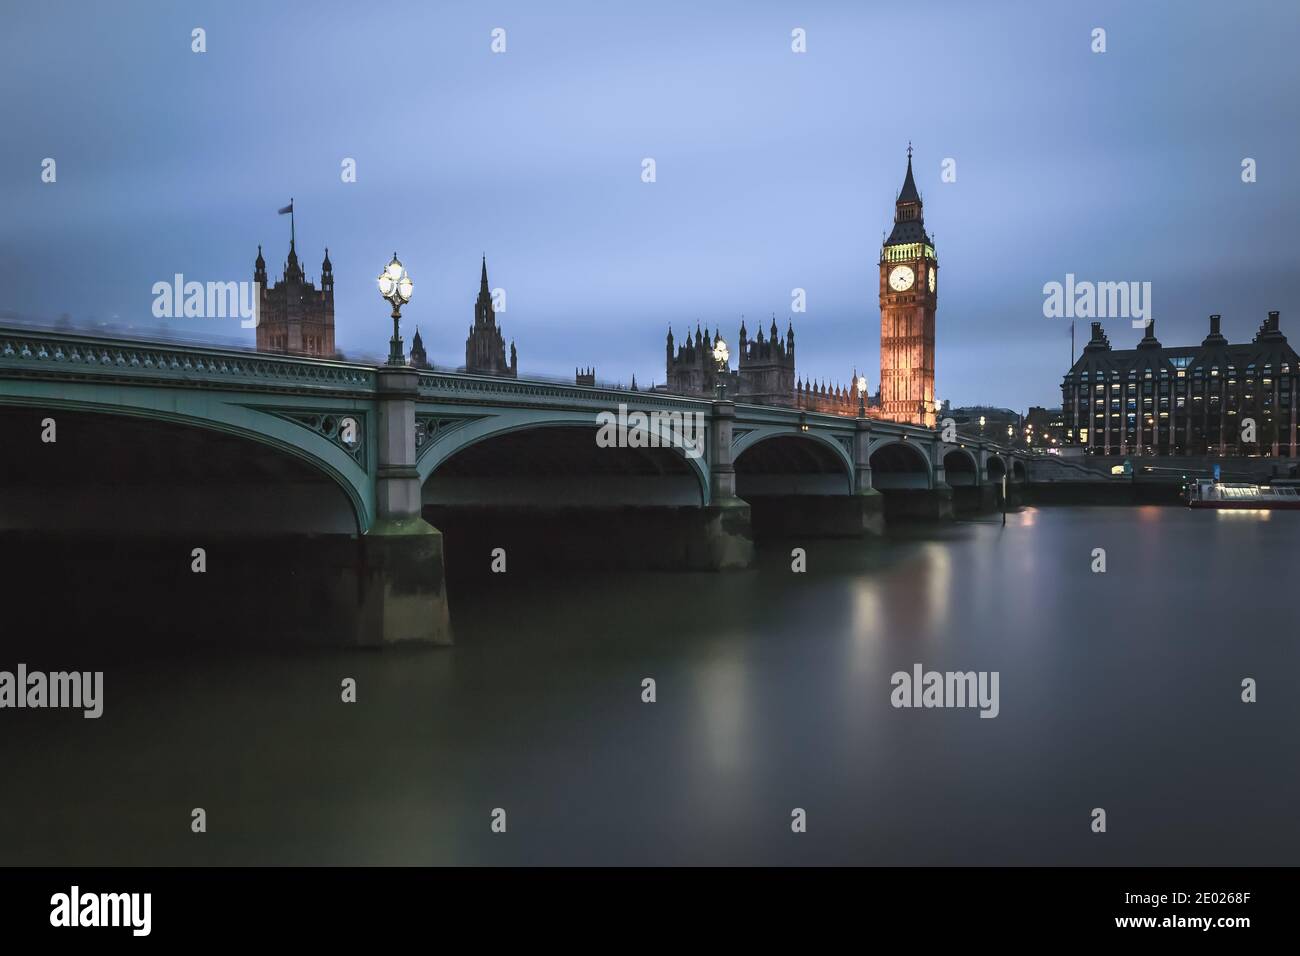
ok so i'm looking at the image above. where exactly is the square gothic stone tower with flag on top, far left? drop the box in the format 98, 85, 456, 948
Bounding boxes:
252, 239, 334, 359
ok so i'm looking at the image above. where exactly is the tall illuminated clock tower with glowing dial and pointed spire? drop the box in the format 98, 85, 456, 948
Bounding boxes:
880, 144, 939, 428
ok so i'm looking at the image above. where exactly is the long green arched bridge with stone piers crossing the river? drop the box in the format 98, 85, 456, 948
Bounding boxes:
0, 326, 1026, 644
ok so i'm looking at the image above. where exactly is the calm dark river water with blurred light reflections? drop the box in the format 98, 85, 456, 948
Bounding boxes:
0, 507, 1300, 864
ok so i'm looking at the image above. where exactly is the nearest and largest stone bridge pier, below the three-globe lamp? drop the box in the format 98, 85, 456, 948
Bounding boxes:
356, 367, 451, 645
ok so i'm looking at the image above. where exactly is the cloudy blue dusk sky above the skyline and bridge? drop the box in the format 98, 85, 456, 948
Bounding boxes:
0, 0, 1300, 410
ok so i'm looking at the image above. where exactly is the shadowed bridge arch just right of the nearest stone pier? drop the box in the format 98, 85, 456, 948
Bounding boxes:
416, 407, 753, 587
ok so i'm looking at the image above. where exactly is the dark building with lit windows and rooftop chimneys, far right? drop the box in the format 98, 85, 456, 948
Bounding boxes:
1061, 312, 1300, 458
